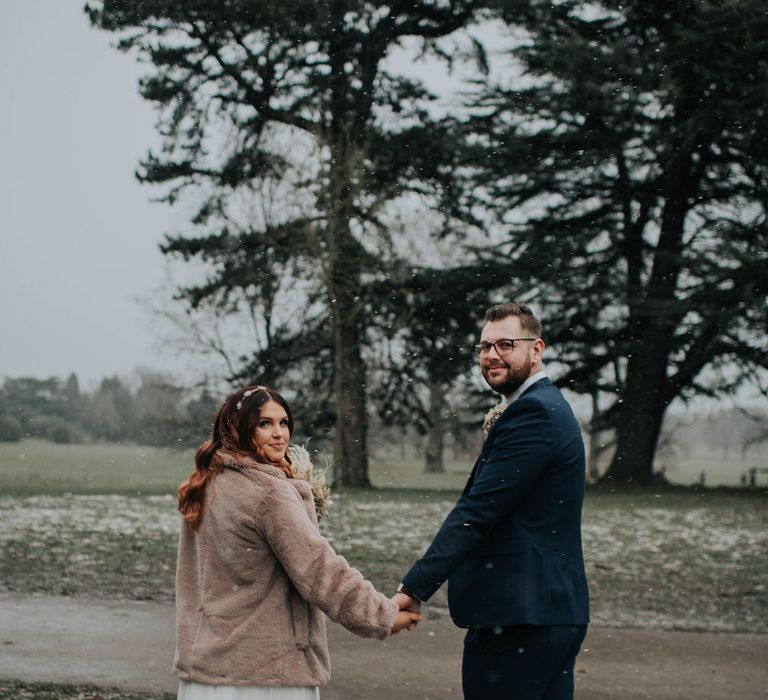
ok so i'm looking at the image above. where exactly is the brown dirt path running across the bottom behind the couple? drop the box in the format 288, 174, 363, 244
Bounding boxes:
0, 594, 768, 700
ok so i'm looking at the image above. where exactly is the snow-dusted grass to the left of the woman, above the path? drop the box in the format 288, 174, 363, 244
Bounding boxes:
0, 495, 178, 599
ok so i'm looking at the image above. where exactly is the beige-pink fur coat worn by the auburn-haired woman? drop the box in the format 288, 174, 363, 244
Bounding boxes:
173, 461, 397, 686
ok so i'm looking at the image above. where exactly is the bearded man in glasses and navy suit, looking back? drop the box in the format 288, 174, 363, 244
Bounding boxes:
395, 304, 589, 700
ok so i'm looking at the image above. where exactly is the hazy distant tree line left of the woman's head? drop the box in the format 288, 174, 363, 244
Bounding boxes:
0, 372, 217, 447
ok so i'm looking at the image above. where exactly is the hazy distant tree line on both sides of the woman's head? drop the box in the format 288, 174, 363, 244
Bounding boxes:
0, 370, 492, 462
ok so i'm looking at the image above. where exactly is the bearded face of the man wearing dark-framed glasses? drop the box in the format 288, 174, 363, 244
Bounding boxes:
480, 316, 543, 396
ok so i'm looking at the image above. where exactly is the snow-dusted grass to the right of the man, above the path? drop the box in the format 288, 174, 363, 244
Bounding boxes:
583, 490, 768, 633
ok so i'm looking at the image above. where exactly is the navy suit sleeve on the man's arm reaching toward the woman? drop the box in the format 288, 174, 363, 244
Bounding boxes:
403, 400, 556, 601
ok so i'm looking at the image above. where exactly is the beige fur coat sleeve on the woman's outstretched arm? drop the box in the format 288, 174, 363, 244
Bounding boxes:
258, 488, 398, 639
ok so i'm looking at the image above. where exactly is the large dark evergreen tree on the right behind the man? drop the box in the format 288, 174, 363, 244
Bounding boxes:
470, 0, 768, 480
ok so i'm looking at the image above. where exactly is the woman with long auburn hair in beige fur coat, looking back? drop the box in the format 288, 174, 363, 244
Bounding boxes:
173, 386, 421, 700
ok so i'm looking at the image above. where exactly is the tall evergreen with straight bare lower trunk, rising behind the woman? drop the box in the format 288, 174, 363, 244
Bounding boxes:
86, 0, 478, 486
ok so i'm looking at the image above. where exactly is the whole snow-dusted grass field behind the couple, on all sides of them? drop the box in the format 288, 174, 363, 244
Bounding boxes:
0, 442, 768, 636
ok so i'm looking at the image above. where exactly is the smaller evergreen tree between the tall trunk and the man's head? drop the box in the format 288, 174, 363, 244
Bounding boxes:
372, 259, 511, 472
